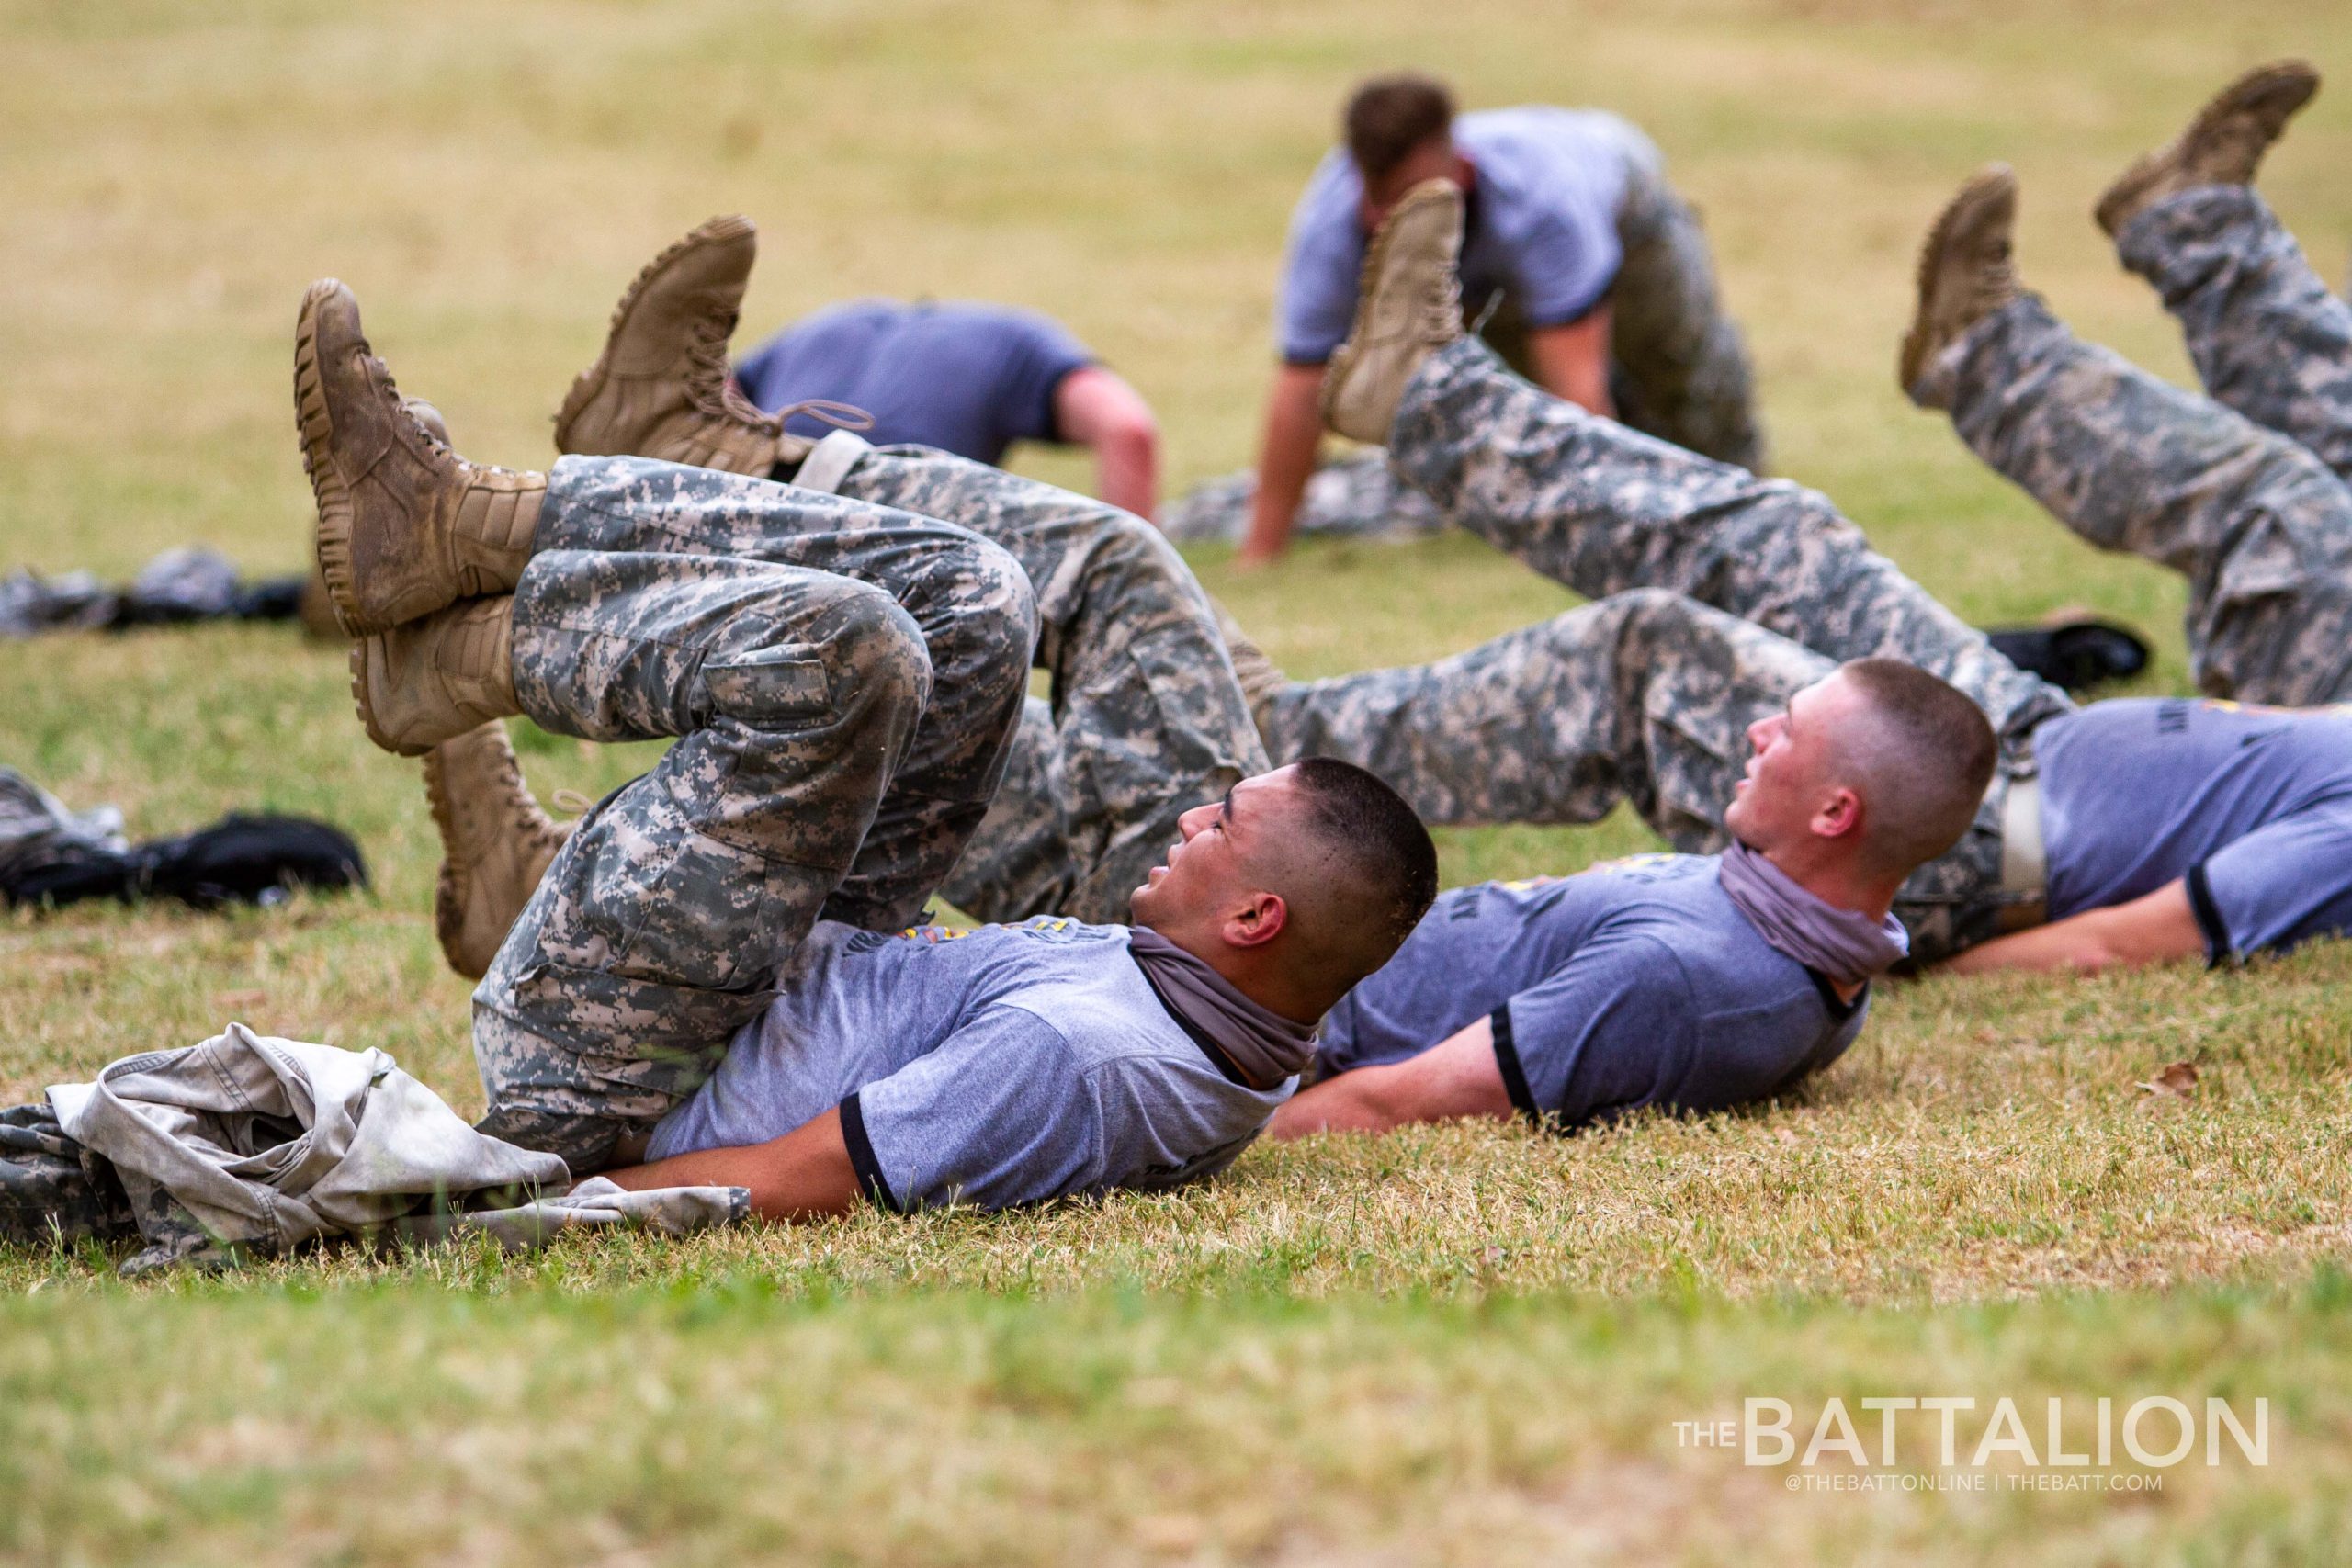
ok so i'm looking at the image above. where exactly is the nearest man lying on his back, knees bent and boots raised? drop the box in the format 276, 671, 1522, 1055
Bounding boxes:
294, 282, 1437, 1218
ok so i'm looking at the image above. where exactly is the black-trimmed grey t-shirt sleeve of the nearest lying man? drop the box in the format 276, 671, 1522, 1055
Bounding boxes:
842, 1006, 1103, 1213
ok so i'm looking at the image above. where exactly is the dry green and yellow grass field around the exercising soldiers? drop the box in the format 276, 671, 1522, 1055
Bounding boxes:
0, 0, 2352, 1568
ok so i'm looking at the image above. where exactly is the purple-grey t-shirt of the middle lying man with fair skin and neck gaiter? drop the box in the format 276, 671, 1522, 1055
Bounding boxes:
1317, 856, 1870, 1128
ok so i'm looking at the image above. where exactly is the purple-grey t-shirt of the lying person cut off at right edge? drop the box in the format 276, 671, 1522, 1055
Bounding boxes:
2034, 698, 2352, 959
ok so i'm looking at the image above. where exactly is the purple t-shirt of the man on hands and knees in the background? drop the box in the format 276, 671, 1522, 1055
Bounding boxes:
1275, 104, 1656, 365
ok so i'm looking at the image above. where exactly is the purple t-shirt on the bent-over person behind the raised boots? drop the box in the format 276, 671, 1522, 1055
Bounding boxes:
734, 299, 1093, 463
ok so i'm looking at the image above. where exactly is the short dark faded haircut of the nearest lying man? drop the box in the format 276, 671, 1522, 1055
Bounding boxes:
1282, 757, 1437, 989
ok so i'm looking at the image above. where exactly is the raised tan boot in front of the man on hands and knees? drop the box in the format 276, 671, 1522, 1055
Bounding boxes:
1322, 179, 1463, 446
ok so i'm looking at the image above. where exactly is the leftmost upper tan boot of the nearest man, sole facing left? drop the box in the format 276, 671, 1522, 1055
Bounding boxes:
294, 277, 548, 637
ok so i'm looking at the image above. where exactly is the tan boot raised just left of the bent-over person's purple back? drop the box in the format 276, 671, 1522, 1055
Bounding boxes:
555, 219, 814, 479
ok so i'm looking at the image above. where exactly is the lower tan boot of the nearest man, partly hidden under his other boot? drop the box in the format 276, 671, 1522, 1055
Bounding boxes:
350, 594, 522, 757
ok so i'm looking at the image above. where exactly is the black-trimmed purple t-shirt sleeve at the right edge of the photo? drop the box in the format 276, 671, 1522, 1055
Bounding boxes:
2188, 802, 2352, 962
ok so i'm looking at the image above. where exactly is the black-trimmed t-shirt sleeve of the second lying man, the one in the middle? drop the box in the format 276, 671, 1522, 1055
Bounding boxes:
1491, 933, 1698, 1128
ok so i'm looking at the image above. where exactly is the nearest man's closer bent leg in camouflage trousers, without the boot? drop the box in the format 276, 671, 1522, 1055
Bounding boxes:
475, 533, 1021, 1170
